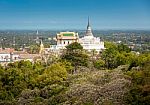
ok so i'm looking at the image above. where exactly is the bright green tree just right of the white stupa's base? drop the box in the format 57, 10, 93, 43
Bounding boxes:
102, 42, 138, 69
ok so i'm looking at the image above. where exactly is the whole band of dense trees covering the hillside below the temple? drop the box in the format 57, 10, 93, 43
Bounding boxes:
0, 42, 150, 105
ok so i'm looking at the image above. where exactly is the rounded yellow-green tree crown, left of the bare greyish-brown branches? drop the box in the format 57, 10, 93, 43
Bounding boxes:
34, 63, 67, 88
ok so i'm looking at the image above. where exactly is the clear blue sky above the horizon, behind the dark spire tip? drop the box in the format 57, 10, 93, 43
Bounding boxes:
0, 0, 150, 30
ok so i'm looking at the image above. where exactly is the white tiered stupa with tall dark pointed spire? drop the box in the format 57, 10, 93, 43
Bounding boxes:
79, 19, 104, 52
